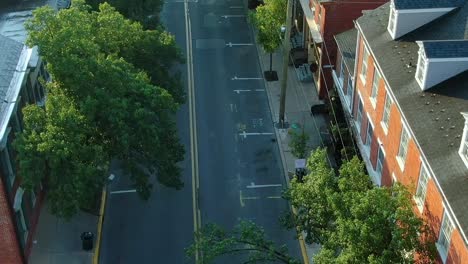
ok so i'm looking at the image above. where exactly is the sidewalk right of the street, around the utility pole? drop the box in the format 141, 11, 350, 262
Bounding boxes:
252, 37, 335, 263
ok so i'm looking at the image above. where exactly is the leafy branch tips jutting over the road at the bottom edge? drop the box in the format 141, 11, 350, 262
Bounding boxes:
186, 221, 300, 264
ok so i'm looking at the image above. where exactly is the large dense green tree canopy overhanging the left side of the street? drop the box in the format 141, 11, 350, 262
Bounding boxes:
16, 0, 184, 215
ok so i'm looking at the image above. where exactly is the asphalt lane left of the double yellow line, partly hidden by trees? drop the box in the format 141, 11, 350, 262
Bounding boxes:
100, 0, 194, 264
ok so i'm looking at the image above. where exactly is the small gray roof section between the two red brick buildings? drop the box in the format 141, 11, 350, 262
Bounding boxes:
335, 28, 357, 75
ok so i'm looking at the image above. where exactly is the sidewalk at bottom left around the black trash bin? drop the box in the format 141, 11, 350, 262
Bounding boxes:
28, 202, 99, 264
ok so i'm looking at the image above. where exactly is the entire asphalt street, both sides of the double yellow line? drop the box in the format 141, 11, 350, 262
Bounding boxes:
100, 0, 301, 264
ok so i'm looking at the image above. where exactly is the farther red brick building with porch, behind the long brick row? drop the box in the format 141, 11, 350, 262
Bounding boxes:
293, 0, 388, 98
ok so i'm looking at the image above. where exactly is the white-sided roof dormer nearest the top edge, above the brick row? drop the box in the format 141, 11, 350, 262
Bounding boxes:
387, 0, 464, 39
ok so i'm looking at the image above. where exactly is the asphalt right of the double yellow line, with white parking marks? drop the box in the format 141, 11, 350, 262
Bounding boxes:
190, 0, 300, 263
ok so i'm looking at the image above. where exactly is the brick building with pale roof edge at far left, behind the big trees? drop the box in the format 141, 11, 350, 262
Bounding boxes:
0, 35, 48, 264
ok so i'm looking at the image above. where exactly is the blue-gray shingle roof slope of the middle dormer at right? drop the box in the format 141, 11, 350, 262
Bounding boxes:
422, 40, 468, 58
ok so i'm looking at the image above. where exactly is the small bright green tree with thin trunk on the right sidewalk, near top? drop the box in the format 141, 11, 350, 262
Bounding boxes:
249, 0, 286, 78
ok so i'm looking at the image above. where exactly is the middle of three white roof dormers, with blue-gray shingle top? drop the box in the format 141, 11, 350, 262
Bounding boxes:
415, 40, 468, 90
